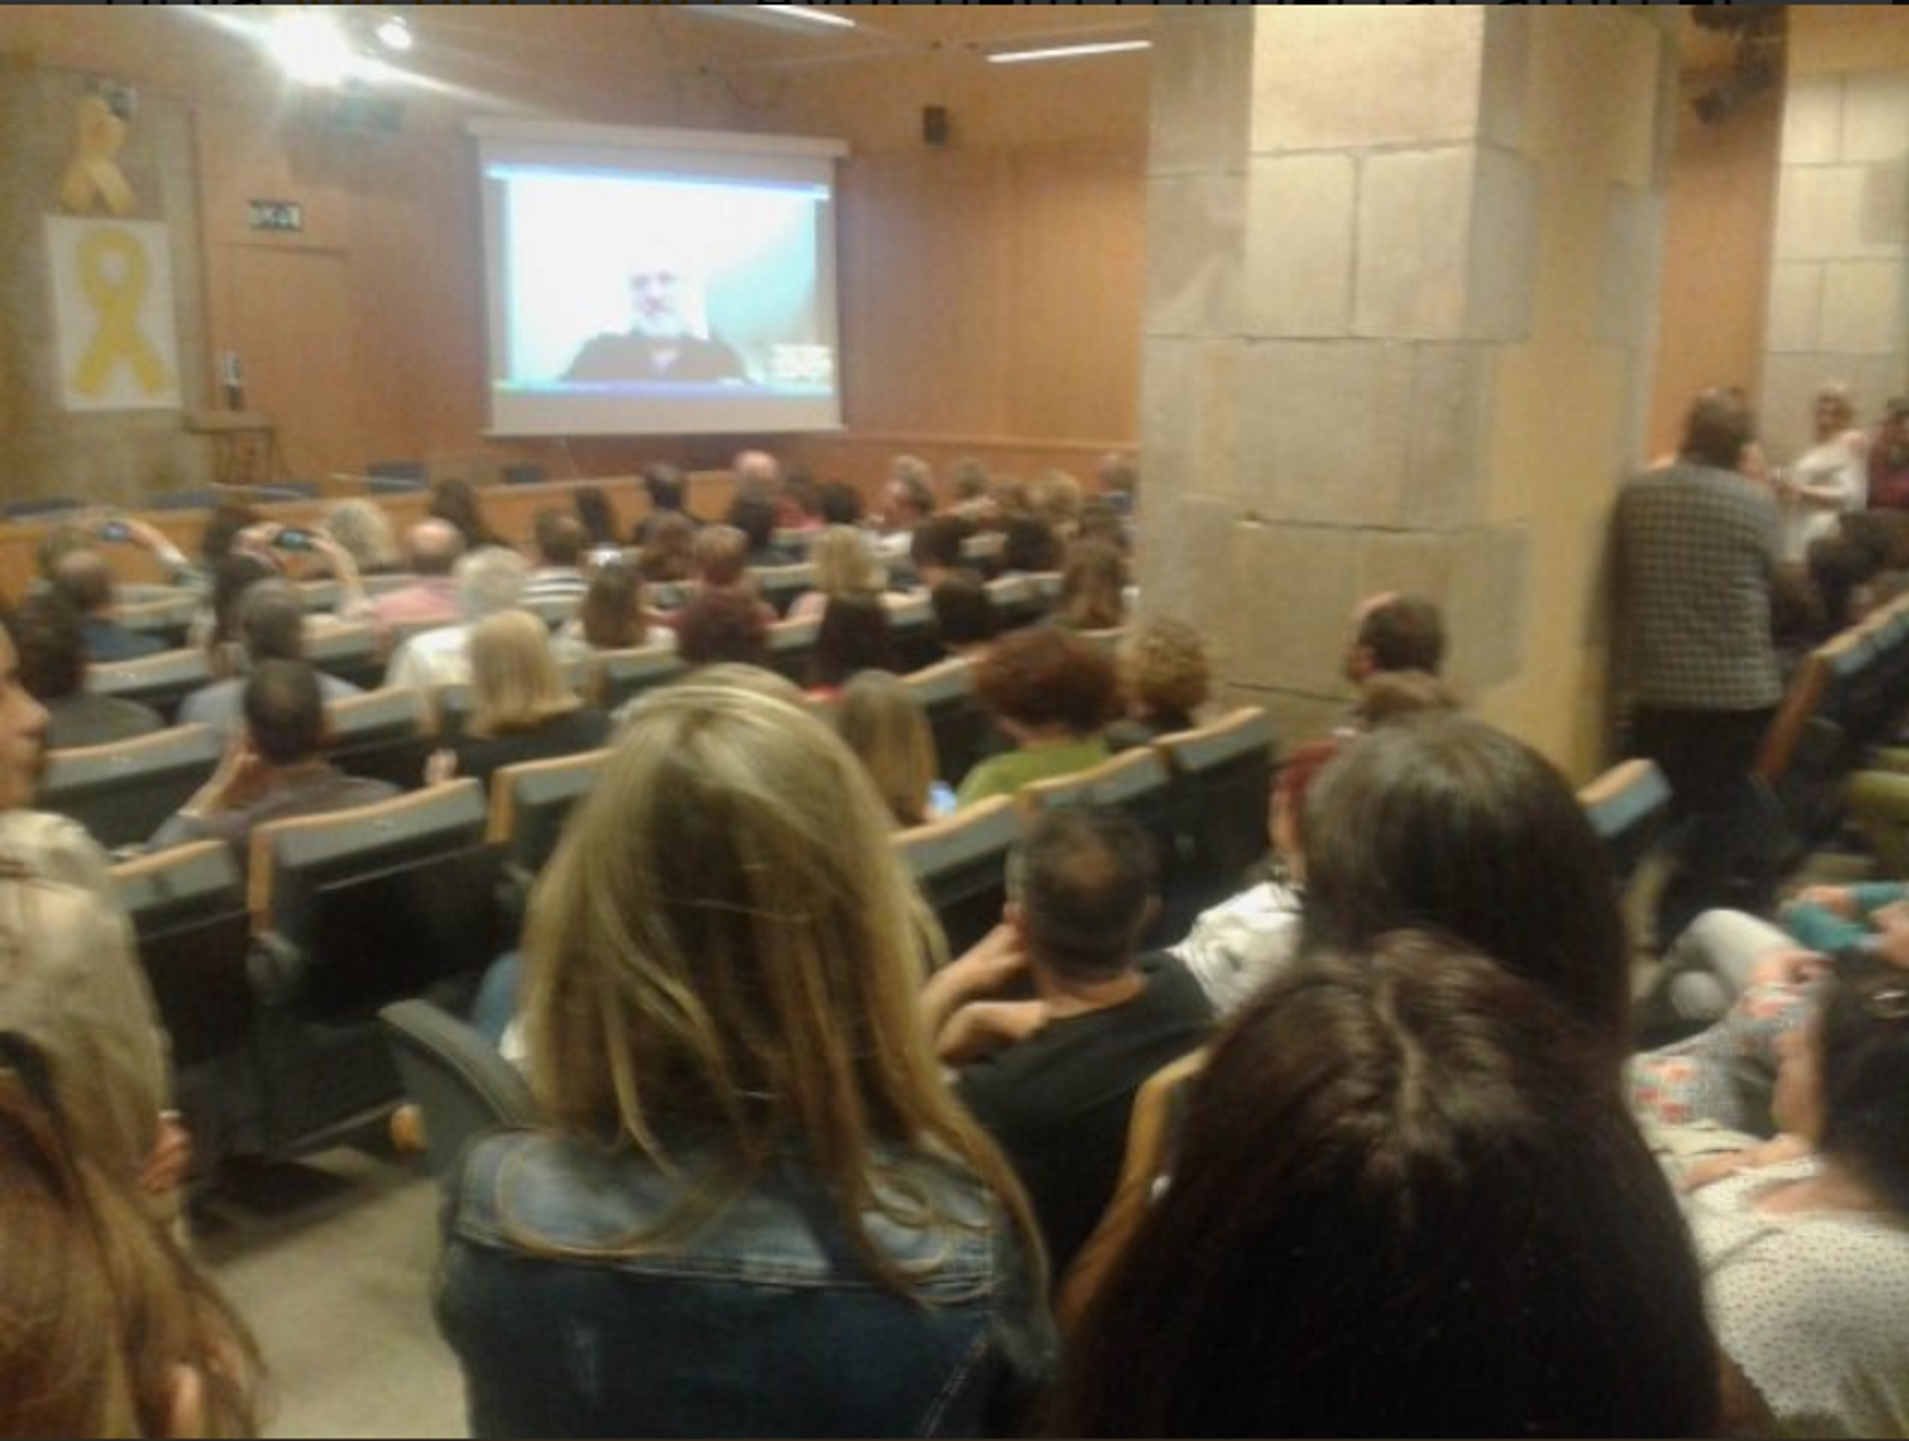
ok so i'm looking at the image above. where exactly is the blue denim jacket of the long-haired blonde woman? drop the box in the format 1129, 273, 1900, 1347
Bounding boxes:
437, 1132, 1056, 1437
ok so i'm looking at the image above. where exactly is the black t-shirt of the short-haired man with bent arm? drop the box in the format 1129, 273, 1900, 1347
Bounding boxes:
955, 954, 1212, 1281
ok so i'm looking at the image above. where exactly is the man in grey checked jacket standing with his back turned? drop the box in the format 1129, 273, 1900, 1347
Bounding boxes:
1617, 389, 1783, 943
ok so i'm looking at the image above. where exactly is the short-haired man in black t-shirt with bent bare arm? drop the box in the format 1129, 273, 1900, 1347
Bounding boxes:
922, 805, 1212, 1273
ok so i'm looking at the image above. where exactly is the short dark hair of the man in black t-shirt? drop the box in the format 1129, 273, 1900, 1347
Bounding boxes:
1008, 805, 1159, 979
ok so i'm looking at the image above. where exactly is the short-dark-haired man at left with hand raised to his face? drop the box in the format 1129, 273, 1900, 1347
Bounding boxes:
151, 660, 397, 868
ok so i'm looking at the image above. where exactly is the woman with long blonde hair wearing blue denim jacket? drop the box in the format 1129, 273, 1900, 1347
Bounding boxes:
437, 683, 1054, 1435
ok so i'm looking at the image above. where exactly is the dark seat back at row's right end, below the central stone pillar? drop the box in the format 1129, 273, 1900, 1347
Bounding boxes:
1153, 706, 1279, 910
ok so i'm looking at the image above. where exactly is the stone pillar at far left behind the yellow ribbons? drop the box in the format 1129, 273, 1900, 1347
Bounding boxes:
0, 67, 212, 506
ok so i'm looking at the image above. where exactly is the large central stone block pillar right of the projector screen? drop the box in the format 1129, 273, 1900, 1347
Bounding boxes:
1142, 6, 1674, 773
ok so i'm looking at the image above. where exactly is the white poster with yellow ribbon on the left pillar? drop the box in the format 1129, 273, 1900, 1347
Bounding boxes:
46, 216, 181, 410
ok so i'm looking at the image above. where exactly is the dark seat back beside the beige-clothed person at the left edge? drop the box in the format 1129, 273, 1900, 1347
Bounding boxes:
113, 840, 252, 1071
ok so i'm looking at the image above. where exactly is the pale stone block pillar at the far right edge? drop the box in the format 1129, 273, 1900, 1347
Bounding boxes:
1762, 59, 1909, 460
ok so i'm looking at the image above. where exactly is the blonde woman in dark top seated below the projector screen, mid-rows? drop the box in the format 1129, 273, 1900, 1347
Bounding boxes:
431, 611, 609, 784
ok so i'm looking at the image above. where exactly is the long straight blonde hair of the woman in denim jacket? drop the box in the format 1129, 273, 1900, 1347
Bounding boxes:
525, 683, 1040, 1290
